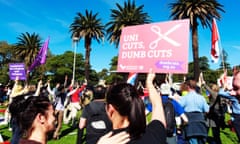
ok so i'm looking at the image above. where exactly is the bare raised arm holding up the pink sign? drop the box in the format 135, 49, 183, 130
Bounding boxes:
146, 71, 166, 127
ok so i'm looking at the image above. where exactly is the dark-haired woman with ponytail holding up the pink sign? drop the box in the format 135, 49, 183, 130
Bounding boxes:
100, 72, 166, 144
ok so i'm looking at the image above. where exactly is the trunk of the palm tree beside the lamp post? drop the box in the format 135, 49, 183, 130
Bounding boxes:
85, 37, 91, 81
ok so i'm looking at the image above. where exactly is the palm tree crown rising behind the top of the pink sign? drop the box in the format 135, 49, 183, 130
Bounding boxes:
106, 0, 150, 47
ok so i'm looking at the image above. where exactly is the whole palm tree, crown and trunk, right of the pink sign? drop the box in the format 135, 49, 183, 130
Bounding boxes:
169, 0, 224, 80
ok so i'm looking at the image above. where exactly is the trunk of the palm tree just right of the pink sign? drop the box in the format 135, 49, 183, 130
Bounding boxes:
192, 18, 200, 81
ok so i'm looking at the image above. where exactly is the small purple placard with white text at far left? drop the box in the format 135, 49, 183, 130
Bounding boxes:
9, 63, 26, 80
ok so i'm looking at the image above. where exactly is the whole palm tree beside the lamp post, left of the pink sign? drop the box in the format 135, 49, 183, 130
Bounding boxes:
70, 10, 104, 80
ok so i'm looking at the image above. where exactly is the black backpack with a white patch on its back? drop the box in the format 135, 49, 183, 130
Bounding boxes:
85, 104, 112, 143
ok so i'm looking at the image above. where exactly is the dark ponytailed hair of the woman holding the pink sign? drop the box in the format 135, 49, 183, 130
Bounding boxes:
106, 83, 146, 138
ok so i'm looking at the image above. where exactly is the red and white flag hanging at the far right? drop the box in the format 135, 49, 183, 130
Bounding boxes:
211, 18, 220, 63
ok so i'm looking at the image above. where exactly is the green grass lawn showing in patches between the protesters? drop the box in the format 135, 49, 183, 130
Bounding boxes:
0, 107, 238, 144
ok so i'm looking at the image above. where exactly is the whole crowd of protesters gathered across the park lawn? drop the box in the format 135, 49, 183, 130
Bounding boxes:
0, 68, 240, 144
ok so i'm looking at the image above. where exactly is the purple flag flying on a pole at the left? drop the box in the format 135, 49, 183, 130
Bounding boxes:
28, 37, 50, 72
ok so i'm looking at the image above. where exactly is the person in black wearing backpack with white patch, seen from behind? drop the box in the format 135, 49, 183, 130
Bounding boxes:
77, 85, 112, 144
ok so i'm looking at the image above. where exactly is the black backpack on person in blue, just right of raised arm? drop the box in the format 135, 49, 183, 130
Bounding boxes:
163, 98, 176, 137
